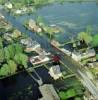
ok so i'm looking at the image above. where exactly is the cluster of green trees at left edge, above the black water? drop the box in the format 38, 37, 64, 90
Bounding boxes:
0, 43, 28, 76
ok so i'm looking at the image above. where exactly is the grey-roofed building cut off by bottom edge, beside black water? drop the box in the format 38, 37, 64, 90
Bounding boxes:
39, 84, 60, 100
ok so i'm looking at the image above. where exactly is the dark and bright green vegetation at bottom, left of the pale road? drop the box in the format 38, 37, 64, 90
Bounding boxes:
58, 77, 85, 100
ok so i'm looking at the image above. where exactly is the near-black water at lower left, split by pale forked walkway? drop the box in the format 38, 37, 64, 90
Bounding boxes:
0, 68, 51, 100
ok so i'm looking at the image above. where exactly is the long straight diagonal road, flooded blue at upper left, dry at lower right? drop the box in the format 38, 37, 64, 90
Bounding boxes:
2, 11, 98, 100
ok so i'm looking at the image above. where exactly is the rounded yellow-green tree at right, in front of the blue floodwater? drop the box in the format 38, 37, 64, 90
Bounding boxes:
78, 32, 92, 45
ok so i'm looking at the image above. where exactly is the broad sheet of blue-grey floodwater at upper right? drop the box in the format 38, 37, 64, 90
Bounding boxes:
17, 2, 98, 42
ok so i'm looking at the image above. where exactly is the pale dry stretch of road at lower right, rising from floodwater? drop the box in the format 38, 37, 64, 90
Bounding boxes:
60, 56, 98, 100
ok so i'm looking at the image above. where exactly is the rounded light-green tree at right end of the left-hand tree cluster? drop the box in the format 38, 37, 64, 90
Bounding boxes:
14, 53, 28, 68
